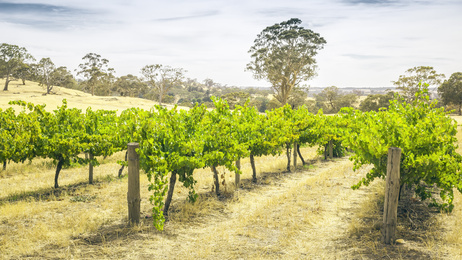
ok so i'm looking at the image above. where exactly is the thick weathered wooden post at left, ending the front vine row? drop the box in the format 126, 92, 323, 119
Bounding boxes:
127, 143, 141, 224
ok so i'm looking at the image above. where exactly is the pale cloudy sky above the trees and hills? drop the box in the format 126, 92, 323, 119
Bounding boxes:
0, 0, 462, 88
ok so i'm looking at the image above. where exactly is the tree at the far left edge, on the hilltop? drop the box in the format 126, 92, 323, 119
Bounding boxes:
0, 43, 33, 91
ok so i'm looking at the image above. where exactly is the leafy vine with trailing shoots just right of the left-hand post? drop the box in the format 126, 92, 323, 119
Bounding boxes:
139, 106, 205, 230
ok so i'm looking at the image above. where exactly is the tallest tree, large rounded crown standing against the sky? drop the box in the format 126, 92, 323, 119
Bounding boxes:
247, 18, 326, 105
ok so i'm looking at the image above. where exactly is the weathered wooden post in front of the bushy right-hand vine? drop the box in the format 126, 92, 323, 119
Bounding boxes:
382, 147, 401, 244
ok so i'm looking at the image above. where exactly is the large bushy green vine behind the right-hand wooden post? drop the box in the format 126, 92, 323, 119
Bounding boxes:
344, 85, 462, 209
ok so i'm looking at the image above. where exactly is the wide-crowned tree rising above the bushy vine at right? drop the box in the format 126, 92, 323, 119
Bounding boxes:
392, 66, 445, 102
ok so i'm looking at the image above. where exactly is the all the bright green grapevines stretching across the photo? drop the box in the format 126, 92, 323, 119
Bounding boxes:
0, 84, 462, 229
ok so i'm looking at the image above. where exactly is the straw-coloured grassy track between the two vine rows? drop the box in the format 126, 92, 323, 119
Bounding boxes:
68, 159, 382, 259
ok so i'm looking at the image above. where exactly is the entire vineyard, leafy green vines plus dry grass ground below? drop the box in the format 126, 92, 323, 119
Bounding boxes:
0, 83, 462, 258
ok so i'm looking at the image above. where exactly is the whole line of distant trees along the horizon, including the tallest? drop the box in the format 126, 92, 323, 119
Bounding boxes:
0, 41, 462, 114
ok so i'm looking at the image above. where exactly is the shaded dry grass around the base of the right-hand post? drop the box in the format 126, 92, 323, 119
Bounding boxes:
335, 186, 448, 259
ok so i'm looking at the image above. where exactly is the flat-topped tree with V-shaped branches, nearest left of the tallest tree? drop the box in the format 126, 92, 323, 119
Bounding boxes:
141, 64, 186, 105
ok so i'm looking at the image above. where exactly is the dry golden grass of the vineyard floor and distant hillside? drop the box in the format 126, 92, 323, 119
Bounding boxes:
0, 82, 462, 259
